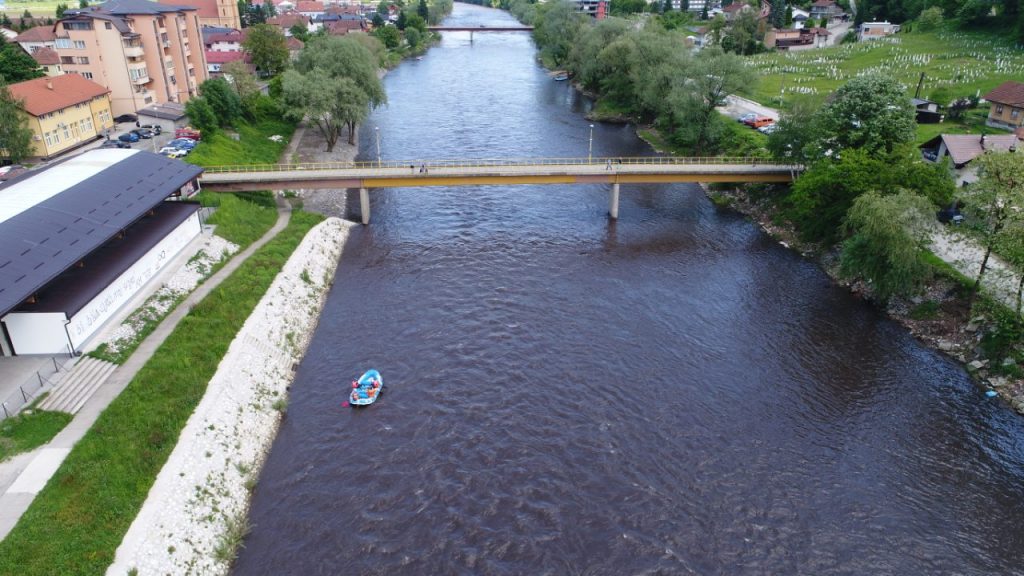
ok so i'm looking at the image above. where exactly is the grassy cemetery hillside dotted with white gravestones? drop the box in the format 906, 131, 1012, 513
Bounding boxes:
743, 30, 1024, 109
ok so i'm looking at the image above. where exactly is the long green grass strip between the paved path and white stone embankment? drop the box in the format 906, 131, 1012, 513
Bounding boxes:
0, 212, 323, 576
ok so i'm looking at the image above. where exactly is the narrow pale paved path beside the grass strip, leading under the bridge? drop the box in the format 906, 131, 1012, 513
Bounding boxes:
0, 194, 301, 540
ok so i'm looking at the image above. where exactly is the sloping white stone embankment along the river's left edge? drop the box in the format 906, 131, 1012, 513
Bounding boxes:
108, 218, 355, 576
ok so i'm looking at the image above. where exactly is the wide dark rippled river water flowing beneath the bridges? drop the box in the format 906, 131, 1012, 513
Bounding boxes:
234, 4, 1024, 575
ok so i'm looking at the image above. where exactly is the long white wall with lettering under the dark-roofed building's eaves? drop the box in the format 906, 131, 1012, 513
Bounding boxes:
67, 213, 202, 354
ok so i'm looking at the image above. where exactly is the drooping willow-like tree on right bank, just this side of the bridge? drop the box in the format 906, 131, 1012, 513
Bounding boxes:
840, 190, 932, 301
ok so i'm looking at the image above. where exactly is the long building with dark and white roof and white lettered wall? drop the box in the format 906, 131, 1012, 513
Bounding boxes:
0, 149, 202, 356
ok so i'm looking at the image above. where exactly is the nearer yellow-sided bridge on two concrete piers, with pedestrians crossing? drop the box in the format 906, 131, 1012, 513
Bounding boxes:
200, 156, 803, 224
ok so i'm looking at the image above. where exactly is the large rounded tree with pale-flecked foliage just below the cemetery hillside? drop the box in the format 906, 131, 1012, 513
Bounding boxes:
818, 76, 918, 155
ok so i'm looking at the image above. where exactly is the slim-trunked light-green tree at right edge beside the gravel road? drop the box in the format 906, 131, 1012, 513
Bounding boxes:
965, 152, 1024, 303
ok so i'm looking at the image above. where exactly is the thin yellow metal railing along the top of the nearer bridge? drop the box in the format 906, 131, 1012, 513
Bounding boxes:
205, 156, 799, 174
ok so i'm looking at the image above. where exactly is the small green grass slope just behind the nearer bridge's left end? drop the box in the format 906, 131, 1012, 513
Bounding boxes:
184, 119, 295, 166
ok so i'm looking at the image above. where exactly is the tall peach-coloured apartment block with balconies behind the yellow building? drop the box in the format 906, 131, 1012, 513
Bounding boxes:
54, 0, 209, 116
